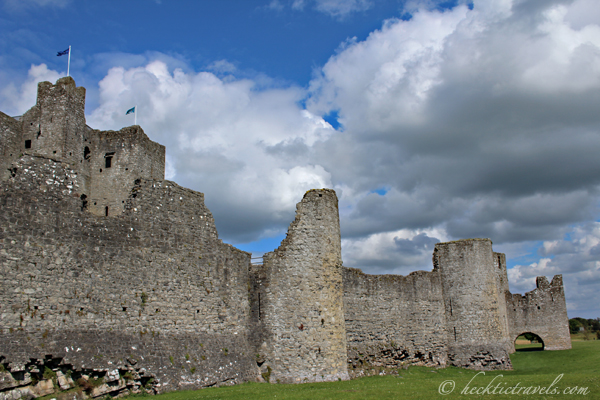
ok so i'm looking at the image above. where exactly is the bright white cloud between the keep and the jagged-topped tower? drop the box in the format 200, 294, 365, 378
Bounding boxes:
88, 60, 334, 241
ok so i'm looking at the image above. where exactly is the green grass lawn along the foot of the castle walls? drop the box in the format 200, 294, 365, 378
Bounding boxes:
124, 341, 600, 400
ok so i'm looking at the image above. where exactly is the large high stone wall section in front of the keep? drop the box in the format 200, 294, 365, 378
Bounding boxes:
0, 156, 258, 390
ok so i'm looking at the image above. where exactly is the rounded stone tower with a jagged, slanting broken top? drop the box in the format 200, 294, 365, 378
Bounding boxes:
255, 189, 348, 383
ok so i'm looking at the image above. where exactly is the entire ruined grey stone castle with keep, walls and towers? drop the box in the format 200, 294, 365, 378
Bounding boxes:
0, 77, 571, 399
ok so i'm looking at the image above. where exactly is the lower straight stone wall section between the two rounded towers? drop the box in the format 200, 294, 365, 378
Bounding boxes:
343, 268, 447, 375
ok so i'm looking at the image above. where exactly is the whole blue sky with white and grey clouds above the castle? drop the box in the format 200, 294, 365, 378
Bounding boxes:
0, 0, 600, 318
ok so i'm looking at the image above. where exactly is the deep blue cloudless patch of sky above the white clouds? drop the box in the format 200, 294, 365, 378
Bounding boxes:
2, 0, 404, 97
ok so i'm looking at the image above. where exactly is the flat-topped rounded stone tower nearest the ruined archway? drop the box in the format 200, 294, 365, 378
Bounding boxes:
433, 239, 512, 369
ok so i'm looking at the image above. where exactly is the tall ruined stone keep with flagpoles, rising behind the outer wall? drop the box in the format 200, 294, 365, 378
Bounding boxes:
1, 77, 165, 216
